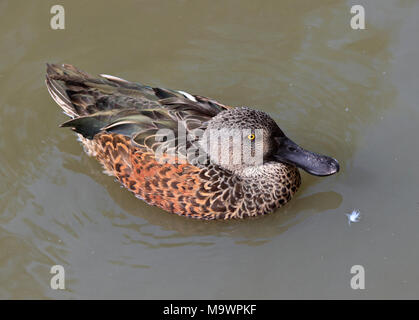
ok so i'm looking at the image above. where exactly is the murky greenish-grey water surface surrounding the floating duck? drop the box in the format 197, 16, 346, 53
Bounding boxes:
0, 0, 419, 299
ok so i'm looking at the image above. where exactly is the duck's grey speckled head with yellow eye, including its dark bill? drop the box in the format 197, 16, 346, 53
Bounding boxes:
203, 107, 339, 176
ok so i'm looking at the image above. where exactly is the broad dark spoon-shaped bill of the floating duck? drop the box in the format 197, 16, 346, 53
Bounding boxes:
274, 136, 339, 176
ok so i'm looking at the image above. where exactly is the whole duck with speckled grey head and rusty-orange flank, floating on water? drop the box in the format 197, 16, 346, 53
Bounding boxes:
45, 63, 339, 220
